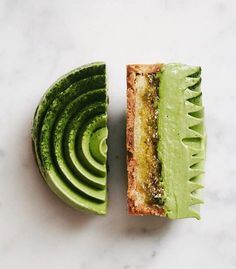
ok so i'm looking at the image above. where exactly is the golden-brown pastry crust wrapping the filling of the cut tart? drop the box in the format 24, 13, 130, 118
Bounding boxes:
126, 64, 165, 216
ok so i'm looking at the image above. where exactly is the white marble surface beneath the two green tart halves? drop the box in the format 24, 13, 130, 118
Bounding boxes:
0, 0, 236, 269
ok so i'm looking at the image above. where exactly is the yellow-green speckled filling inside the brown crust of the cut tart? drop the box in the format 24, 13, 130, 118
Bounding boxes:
135, 74, 163, 206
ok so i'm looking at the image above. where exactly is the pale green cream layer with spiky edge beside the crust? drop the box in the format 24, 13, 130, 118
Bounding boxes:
157, 64, 205, 219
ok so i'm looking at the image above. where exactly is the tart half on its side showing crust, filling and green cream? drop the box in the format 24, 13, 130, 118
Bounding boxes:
127, 64, 205, 219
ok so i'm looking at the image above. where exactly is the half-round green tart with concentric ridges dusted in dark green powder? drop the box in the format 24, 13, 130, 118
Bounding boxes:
32, 63, 108, 215
